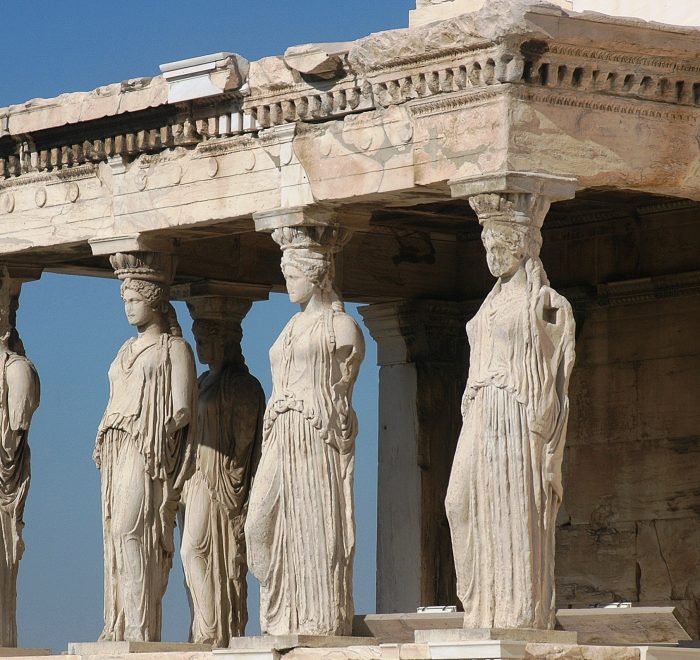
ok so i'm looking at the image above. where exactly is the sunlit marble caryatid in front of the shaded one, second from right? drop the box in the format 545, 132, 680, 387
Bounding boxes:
245, 227, 365, 635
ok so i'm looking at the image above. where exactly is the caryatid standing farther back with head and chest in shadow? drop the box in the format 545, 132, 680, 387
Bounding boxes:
181, 296, 265, 648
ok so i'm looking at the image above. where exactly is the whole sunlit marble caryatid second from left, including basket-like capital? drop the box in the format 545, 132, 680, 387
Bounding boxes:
94, 252, 197, 642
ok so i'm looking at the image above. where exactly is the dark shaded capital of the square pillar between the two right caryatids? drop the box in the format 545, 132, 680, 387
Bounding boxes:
359, 300, 478, 368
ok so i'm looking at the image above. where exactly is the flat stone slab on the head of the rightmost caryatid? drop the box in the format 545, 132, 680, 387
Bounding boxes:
447, 172, 576, 202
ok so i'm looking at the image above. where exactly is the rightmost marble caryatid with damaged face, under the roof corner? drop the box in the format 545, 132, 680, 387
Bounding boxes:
446, 194, 574, 629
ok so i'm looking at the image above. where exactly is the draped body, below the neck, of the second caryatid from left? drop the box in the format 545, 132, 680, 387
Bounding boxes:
94, 334, 196, 641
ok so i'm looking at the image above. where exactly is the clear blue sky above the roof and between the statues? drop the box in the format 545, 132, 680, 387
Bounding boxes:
0, 0, 414, 652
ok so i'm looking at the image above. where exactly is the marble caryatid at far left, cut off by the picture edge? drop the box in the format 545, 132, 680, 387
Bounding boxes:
0, 270, 39, 646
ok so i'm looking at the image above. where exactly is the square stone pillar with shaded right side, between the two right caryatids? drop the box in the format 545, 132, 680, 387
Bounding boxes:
360, 300, 471, 613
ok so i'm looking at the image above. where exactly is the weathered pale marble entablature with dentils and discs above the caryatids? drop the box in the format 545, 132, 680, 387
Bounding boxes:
0, 2, 700, 266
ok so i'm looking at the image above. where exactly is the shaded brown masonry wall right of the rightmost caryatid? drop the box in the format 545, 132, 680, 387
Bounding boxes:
552, 206, 700, 636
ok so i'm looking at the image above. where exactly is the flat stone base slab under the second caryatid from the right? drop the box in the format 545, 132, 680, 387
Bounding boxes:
213, 635, 377, 660
